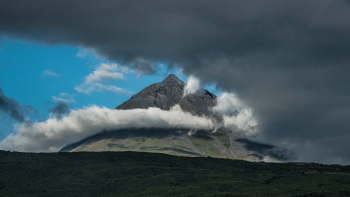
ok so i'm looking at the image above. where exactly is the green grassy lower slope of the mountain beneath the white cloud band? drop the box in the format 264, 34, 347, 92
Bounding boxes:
61, 129, 261, 160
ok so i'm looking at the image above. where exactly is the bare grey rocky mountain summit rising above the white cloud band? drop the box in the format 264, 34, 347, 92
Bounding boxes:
116, 74, 216, 116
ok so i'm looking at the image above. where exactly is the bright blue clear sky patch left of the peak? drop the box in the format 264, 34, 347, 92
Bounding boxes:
0, 38, 218, 140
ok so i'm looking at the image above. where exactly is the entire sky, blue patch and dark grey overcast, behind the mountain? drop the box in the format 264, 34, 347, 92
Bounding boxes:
0, 0, 350, 164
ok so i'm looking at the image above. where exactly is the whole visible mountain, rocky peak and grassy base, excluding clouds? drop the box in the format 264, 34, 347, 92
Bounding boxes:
61, 74, 285, 161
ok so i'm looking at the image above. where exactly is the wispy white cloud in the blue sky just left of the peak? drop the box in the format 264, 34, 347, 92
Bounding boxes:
74, 63, 134, 94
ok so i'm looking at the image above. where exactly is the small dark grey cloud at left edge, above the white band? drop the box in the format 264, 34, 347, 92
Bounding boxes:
0, 88, 28, 122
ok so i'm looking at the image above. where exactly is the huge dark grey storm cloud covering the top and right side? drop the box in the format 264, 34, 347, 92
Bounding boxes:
0, 0, 350, 163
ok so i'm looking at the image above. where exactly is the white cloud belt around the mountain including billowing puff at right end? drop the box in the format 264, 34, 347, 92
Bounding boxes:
0, 90, 257, 152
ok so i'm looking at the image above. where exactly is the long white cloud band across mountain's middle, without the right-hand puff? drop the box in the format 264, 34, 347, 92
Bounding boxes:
0, 106, 214, 152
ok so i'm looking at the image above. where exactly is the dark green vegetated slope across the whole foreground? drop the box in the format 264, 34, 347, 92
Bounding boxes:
0, 151, 350, 197
